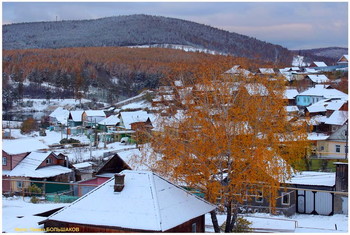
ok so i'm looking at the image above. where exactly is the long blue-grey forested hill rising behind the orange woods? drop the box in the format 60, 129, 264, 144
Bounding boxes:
3, 15, 292, 64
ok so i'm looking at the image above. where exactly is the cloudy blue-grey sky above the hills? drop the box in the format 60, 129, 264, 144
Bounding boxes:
2, 2, 348, 49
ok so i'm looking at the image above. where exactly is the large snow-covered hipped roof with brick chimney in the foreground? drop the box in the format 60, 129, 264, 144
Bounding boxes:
47, 170, 215, 232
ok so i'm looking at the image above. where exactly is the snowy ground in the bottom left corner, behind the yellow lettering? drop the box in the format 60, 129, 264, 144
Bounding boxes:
1, 197, 68, 233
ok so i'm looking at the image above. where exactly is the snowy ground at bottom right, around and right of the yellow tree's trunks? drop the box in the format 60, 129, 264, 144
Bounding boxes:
205, 213, 348, 233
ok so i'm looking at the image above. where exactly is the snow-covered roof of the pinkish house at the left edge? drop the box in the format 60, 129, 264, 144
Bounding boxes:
2, 138, 49, 154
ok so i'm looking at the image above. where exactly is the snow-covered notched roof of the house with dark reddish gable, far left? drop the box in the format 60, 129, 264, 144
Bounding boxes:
9, 152, 72, 178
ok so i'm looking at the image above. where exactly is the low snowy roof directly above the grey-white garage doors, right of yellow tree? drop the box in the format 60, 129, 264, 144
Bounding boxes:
286, 171, 335, 187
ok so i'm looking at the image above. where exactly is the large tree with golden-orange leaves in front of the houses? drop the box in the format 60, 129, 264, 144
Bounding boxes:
139, 64, 307, 232
